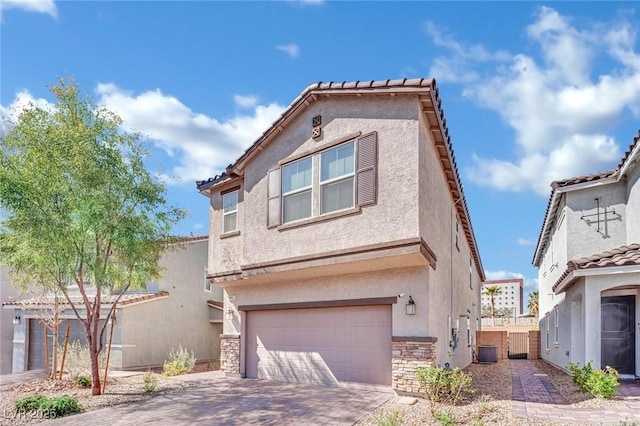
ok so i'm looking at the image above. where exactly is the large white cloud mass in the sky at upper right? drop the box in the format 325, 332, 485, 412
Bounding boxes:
427, 7, 640, 195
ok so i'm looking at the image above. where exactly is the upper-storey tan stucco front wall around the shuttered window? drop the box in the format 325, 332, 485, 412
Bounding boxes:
209, 96, 419, 272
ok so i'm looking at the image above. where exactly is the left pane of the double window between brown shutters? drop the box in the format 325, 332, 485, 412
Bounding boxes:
282, 157, 313, 223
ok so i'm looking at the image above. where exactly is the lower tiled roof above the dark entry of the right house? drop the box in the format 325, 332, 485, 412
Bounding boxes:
553, 243, 640, 292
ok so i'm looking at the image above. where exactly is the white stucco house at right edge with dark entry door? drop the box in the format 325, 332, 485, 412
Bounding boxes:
533, 132, 640, 377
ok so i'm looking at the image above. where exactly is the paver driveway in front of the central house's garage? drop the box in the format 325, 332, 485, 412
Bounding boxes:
47, 373, 394, 426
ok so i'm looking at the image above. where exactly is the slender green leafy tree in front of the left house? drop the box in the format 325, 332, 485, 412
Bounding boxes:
0, 79, 184, 395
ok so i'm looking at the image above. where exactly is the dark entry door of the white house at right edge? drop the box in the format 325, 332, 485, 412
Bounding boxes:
600, 296, 636, 375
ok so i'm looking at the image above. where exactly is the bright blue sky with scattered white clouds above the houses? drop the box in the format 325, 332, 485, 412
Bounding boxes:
0, 0, 640, 298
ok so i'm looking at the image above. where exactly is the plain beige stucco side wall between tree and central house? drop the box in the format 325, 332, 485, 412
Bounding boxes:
118, 240, 222, 368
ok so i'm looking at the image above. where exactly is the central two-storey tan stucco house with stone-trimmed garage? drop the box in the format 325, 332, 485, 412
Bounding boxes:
197, 79, 484, 392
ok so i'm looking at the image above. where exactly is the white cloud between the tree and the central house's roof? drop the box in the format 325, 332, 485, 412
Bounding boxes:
96, 84, 284, 183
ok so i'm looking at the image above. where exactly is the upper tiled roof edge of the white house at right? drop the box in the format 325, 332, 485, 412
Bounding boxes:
532, 129, 640, 266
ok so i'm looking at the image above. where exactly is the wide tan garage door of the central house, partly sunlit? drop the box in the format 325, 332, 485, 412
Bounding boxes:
246, 305, 391, 385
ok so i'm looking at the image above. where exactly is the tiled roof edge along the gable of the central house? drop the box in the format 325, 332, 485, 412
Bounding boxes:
196, 78, 484, 279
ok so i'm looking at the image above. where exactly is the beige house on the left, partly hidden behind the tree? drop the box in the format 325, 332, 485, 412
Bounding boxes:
3, 236, 222, 373
